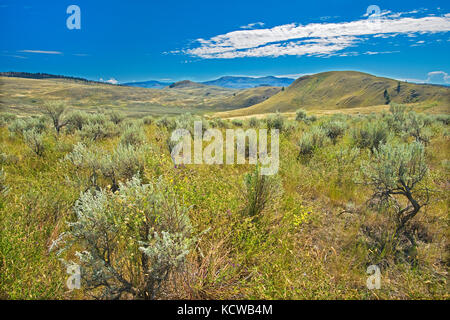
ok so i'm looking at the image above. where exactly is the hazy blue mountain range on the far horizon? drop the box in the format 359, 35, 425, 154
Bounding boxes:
123, 76, 295, 89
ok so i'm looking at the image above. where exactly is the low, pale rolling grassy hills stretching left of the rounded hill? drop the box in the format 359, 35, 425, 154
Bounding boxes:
0, 77, 277, 116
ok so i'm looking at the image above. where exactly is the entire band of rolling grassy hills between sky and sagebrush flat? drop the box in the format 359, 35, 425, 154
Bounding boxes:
0, 72, 450, 119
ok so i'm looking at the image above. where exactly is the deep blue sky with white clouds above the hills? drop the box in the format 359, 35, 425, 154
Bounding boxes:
0, 0, 450, 84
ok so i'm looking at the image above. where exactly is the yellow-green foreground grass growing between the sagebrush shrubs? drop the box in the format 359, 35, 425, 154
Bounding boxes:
0, 104, 450, 299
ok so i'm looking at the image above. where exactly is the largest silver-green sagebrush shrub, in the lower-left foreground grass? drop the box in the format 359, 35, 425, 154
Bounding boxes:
60, 177, 195, 299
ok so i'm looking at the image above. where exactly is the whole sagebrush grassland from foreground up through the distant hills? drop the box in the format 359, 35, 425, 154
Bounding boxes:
0, 73, 450, 299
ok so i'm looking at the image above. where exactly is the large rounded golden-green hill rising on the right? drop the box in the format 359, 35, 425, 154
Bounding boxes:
219, 71, 450, 117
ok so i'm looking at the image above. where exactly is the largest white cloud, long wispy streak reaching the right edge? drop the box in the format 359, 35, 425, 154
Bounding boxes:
182, 11, 450, 59
